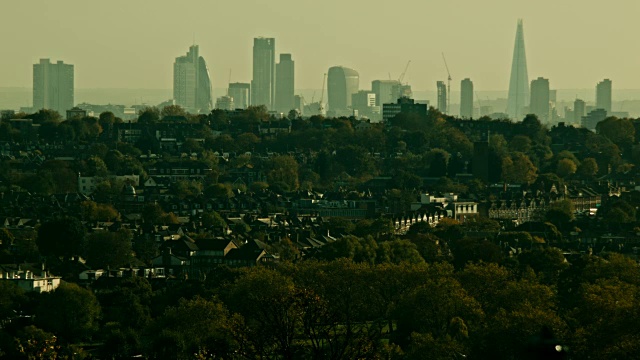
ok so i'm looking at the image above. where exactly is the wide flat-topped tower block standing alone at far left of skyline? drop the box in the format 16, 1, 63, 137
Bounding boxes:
33, 59, 74, 116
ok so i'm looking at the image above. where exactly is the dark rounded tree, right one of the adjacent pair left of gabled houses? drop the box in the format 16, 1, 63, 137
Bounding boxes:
87, 229, 133, 269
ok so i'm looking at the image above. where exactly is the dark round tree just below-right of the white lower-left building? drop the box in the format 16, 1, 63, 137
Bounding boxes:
36, 283, 100, 342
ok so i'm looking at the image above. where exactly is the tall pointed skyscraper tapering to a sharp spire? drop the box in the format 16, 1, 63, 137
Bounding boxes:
507, 20, 529, 120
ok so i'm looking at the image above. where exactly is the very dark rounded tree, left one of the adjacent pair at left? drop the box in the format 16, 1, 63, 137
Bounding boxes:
36, 217, 87, 260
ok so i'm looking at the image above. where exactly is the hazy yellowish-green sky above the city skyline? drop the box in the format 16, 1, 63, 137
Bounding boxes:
0, 0, 640, 90
